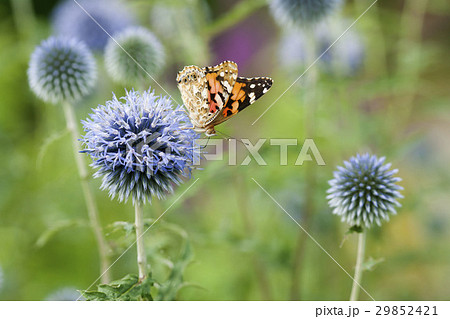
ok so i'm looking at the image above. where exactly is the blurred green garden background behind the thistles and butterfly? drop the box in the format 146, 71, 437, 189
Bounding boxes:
0, 0, 450, 300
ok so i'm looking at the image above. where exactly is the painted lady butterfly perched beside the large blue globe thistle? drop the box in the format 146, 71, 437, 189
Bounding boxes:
177, 61, 273, 136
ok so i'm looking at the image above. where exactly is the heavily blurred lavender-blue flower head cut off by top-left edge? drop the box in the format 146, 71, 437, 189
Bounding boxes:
52, 0, 135, 51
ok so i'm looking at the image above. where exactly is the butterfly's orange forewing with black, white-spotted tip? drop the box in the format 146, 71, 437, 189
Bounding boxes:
211, 77, 273, 126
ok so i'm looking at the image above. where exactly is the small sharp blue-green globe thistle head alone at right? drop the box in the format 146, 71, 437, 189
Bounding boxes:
327, 154, 403, 228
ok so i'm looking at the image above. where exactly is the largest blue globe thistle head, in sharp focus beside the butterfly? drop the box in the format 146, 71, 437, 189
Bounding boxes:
82, 90, 199, 203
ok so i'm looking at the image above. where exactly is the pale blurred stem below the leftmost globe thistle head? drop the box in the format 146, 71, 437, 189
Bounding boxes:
63, 102, 110, 283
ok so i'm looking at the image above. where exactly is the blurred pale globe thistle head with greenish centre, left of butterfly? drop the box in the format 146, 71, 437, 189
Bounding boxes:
105, 27, 164, 83
